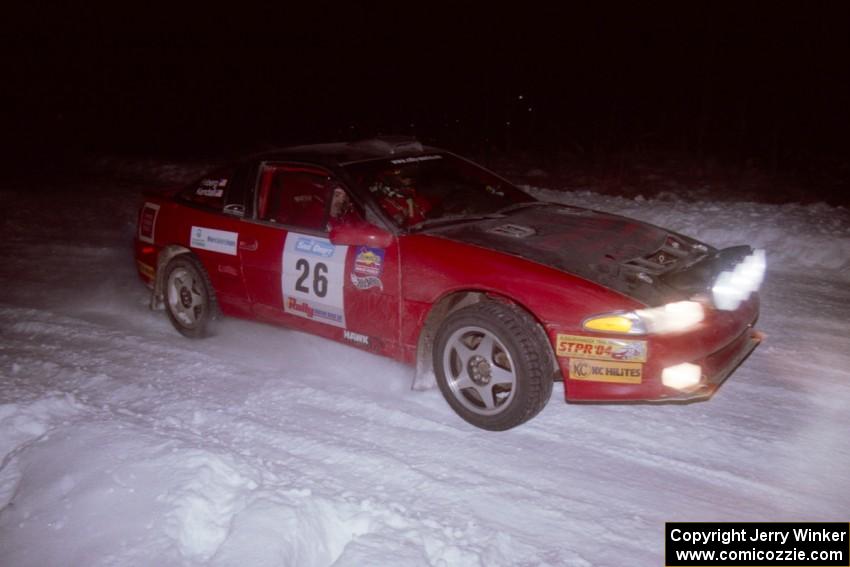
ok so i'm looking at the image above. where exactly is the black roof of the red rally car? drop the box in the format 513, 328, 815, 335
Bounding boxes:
248, 136, 441, 167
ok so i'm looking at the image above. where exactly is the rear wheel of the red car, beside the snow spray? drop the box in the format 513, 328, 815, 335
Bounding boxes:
165, 254, 216, 338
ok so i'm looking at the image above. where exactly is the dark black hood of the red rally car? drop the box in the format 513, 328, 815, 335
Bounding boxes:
427, 203, 727, 306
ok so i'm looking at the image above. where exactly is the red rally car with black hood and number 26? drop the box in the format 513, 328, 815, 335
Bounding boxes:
135, 138, 765, 430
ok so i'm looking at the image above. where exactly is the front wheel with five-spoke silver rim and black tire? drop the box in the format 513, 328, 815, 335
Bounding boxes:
434, 301, 553, 431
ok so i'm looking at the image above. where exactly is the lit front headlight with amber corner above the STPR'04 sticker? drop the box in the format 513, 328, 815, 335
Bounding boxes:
582, 301, 705, 335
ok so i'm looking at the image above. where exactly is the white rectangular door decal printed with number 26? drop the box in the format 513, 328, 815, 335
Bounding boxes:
281, 232, 348, 327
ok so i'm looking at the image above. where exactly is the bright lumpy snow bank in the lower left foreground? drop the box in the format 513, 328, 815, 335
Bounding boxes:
0, 403, 552, 567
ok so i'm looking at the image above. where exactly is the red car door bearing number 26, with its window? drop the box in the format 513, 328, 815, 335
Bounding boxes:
239, 163, 399, 354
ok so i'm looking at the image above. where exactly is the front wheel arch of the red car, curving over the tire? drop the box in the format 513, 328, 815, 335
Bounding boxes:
413, 289, 562, 390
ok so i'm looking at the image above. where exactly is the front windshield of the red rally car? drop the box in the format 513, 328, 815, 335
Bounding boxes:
346, 153, 536, 230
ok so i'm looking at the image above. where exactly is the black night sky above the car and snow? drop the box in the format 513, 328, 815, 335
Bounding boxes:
2, 2, 850, 166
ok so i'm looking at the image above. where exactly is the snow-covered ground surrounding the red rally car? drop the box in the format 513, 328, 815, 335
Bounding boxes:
0, 162, 850, 567
